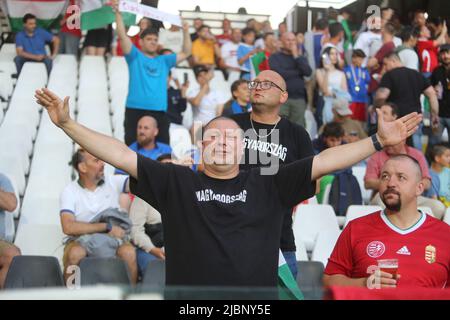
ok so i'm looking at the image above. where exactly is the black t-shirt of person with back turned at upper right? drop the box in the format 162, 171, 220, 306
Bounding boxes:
379, 67, 430, 117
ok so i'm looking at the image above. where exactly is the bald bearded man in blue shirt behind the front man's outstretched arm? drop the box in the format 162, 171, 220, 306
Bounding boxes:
115, 116, 172, 174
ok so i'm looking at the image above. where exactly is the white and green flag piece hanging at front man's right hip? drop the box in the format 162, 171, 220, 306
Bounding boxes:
278, 250, 304, 300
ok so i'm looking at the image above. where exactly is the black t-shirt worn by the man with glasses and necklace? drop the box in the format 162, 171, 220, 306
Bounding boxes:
231, 113, 314, 251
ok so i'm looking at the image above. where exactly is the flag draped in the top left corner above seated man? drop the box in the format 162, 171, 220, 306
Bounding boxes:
0, 0, 67, 32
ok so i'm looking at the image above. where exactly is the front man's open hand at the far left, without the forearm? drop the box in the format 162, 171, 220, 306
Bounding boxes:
34, 88, 71, 128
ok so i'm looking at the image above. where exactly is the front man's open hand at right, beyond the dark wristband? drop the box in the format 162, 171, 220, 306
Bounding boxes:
376, 109, 422, 147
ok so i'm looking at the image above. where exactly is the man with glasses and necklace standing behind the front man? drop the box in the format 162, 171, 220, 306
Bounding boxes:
231, 70, 314, 278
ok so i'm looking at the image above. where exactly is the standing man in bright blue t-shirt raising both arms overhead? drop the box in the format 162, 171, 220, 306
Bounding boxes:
112, 0, 192, 145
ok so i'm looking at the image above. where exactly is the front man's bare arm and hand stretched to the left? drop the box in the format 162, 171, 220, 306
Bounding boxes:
35, 89, 137, 179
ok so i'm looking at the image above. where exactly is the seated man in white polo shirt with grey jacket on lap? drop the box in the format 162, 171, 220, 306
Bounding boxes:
60, 149, 137, 283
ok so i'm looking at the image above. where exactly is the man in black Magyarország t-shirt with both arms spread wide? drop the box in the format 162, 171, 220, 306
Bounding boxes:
36, 89, 422, 287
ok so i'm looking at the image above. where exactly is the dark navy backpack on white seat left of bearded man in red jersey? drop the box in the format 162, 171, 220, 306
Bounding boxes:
328, 169, 363, 216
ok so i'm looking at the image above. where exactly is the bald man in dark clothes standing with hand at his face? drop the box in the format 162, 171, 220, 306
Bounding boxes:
269, 32, 312, 127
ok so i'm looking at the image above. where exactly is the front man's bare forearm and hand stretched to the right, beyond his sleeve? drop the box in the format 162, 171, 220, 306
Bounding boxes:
311, 109, 422, 180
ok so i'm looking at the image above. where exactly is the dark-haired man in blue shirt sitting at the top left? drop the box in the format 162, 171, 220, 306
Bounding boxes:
14, 13, 59, 74
